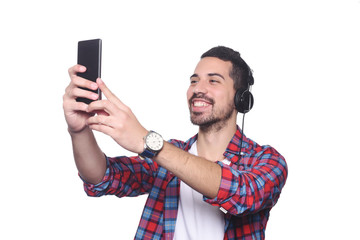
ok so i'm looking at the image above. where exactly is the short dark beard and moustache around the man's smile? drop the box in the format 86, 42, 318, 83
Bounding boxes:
189, 94, 235, 132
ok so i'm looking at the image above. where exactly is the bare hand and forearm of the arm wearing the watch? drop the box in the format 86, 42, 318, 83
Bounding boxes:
87, 79, 221, 197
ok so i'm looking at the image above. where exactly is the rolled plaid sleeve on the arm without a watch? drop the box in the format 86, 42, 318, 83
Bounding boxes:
82, 156, 158, 197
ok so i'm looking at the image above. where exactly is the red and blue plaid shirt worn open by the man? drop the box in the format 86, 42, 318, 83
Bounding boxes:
84, 128, 287, 240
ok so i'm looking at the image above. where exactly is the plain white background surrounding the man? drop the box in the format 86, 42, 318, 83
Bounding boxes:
0, 0, 360, 240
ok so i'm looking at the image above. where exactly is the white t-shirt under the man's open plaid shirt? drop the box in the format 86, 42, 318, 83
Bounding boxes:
174, 142, 225, 240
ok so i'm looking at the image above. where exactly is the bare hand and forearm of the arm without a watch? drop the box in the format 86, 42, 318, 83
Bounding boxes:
63, 65, 106, 183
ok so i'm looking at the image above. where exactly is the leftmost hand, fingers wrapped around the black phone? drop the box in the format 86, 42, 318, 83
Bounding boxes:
63, 65, 98, 133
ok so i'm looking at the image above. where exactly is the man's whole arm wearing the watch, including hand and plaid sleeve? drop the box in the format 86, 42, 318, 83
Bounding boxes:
83, 79, 287, 215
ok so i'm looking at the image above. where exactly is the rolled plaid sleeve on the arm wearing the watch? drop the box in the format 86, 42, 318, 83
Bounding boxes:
204, 146, 287, 215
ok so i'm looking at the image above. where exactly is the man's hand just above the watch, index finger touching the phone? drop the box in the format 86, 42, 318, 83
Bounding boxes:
87, 78, 148, 153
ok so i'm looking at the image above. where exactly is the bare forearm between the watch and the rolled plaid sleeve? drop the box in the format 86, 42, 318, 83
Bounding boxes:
155, 142, 221, 198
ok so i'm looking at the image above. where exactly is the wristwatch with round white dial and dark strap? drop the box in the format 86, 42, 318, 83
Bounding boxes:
139, 131, 164, 158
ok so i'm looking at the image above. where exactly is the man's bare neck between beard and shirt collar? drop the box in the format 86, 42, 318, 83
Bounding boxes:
197, 117, 237, 162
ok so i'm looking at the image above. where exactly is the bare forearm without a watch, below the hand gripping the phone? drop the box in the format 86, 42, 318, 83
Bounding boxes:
69, 128, 106, 184
